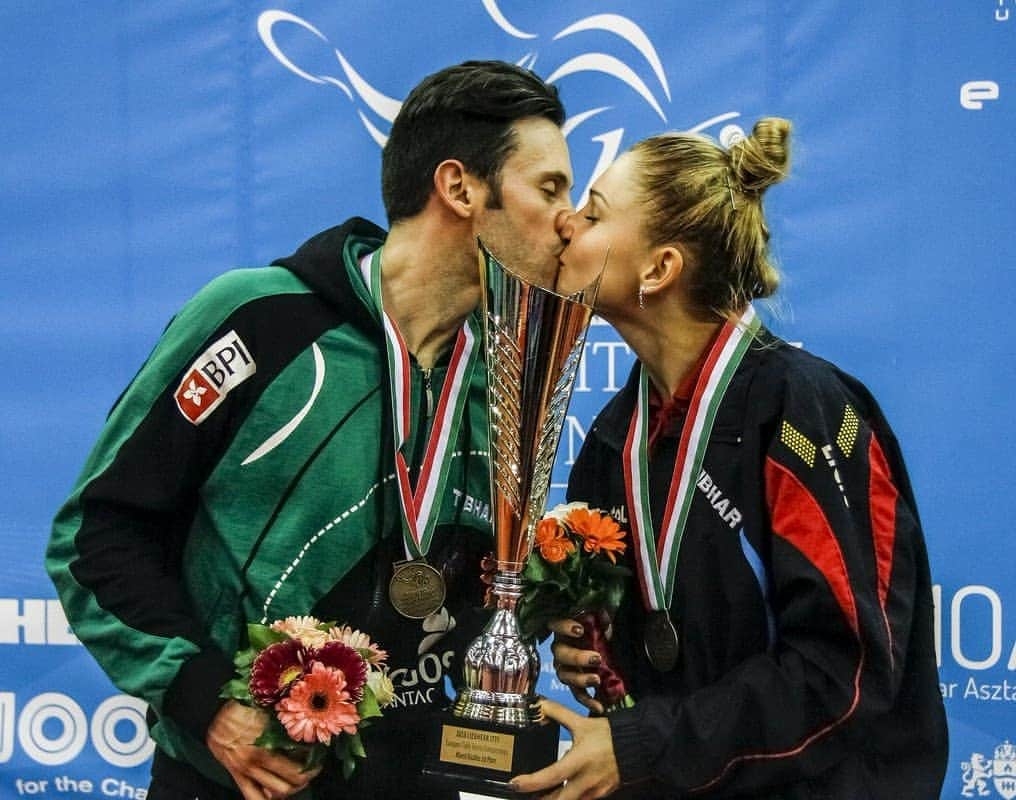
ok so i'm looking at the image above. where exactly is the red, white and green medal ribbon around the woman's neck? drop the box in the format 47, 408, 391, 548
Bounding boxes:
624, 305, 762, 611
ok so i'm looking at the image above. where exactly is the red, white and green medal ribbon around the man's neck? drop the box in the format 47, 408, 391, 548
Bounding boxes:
360, 249, 481, 559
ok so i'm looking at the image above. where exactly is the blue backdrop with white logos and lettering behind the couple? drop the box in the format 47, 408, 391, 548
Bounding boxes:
0, 0, 1016, 798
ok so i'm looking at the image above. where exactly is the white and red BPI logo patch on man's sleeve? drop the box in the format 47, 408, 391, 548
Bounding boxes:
175, 330, 257, 425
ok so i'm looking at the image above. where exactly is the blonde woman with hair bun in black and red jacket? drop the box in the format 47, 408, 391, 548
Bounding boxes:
514, 118, 947, 800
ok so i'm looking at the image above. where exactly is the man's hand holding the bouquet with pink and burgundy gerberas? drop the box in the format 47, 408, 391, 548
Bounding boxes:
205, 700, 320, 800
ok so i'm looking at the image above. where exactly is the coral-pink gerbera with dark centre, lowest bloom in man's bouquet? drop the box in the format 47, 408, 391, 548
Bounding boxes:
275, 662, 360, 744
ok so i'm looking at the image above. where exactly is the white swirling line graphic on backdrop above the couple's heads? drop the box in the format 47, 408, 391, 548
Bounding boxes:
257, 0, 745, 206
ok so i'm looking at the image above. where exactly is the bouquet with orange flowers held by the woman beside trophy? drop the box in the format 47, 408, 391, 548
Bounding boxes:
518, 503, 634, 711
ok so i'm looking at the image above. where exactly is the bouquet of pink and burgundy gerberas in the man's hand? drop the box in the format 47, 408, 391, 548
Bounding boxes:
221, 617, 394, 778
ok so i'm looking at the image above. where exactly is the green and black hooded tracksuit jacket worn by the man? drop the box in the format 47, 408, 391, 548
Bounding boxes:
47, 219, 490, 796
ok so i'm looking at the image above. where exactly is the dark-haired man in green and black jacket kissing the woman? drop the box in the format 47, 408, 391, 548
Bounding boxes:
47, 62, 571, 800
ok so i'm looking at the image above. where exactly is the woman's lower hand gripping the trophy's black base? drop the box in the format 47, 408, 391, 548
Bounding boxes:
511, 700, 621, 800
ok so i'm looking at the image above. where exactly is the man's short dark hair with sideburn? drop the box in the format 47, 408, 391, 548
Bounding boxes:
381, 61, 565, 225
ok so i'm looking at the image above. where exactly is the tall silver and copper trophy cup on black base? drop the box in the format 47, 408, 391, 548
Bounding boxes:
424, 243, 599, 797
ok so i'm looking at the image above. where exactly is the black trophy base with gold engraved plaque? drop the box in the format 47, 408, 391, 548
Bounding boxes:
423, 712, 561, 797
